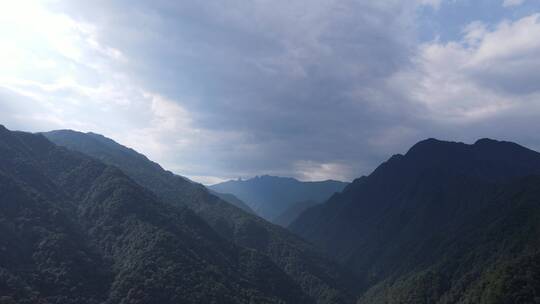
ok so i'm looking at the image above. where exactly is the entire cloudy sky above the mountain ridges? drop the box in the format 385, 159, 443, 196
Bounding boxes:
0, 0, 540, 184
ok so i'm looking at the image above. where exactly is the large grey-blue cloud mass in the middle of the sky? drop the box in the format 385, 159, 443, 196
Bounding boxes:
41, 0, 422, 179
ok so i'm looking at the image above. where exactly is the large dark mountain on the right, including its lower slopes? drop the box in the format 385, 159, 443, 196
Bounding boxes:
290, 139, 540, 303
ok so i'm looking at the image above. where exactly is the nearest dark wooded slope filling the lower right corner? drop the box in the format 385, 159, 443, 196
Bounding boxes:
358, 176, 540, 304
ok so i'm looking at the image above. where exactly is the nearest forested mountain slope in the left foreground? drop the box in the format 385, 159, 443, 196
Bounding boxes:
0, 126, 313, 304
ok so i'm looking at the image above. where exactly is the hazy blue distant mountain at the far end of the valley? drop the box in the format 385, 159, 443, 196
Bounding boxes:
209, 175, 347, 222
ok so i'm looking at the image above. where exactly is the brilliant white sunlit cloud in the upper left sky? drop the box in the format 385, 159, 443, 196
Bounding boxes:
0, 0, 226, 182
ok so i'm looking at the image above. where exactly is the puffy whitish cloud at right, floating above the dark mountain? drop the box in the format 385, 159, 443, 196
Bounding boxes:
390, 14, 540, 124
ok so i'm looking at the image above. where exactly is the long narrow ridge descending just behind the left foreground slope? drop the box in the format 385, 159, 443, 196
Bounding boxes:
44, 130, 358, 304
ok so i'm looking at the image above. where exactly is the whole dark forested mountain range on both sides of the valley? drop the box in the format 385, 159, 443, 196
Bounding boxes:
0, 126, 540, 304
